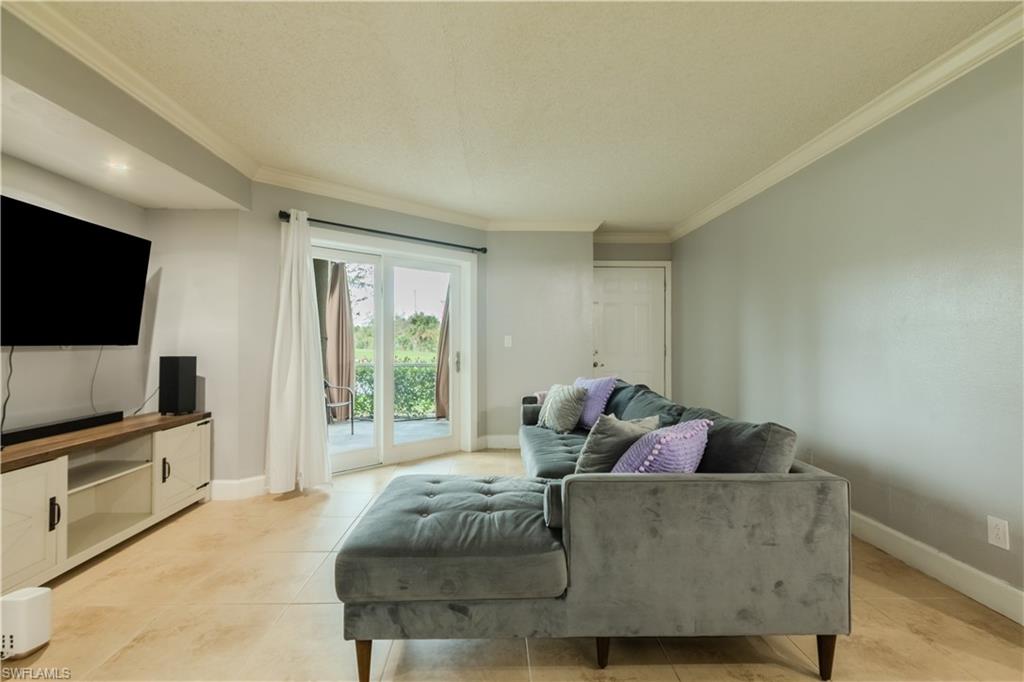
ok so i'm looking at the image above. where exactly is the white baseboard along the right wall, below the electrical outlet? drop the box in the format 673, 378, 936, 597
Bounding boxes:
851, 512, 1024, 625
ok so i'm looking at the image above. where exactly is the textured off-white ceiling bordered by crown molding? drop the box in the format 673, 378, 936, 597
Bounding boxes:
48, 2, 1013, 229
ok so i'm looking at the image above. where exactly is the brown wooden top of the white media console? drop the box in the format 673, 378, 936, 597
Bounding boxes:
0, 412, 212, 472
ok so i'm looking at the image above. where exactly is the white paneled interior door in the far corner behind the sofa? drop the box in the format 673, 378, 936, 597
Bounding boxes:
593, 265, 668, 395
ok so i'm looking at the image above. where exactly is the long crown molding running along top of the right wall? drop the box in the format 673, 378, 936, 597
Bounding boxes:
671, 5, 1024, 240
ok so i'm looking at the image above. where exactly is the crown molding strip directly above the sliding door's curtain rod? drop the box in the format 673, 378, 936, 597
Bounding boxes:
253, 166, 488, 230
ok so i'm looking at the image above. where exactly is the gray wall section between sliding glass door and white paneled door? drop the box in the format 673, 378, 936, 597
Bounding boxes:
484, 232, 594, 435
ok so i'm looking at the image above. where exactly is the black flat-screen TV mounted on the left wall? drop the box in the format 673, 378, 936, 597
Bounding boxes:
0, 197, 151, 346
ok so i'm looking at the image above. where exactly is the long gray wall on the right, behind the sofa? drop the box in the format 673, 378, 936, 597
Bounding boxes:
673, 46, 1024, 587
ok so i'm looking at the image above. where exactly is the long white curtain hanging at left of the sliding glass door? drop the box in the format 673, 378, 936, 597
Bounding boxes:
266, 209, 331, 493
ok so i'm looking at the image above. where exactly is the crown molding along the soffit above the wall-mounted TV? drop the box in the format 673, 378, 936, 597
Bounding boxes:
3, 2, 259, 178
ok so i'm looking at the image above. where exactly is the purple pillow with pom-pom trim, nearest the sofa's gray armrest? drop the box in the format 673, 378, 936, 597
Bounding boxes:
611, 419, 713, 473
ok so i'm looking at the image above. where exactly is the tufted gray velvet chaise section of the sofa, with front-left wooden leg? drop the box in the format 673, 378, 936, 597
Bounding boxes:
335, 475, 567, 680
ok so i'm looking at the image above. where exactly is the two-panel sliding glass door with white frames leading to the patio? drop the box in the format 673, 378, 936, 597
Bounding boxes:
313, 247, 461, 471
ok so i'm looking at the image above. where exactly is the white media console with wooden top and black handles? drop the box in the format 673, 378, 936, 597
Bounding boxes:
0, 413, 213, 593
